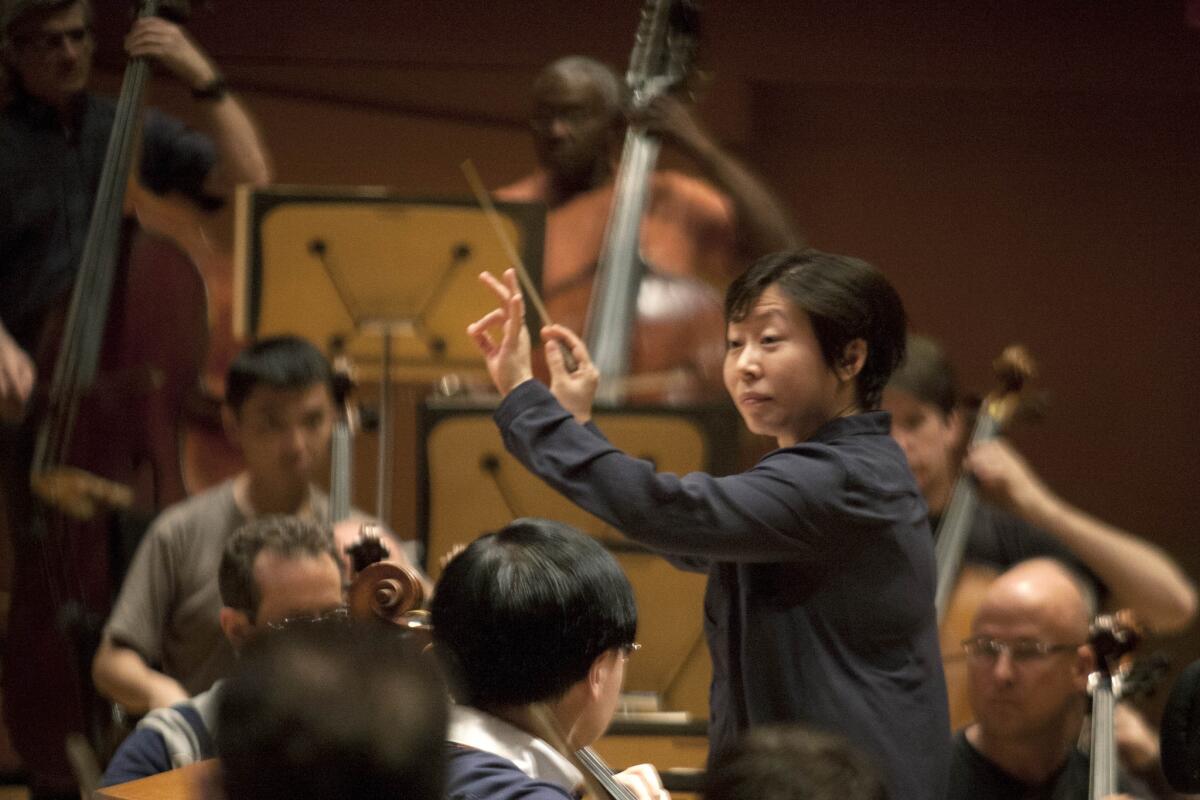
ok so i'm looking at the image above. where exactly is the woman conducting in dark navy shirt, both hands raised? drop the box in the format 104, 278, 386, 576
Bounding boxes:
468, 249, 949, 800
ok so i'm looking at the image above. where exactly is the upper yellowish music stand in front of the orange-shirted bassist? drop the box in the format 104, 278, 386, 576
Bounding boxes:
234, 186, 546, 523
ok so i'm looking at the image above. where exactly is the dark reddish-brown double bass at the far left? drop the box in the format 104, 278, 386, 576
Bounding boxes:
4, 0, 208, 790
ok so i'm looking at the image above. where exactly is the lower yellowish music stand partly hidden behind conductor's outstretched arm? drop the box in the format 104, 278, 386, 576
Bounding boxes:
420, 397, 738, 720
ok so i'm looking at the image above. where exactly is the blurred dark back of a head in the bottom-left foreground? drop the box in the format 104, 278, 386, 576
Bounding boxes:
216, 624, 446, 800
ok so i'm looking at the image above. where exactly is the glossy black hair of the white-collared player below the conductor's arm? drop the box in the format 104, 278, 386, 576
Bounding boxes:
432, 518, 637, 709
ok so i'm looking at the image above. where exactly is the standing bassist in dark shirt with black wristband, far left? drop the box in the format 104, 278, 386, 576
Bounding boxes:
0, 0, 270, 421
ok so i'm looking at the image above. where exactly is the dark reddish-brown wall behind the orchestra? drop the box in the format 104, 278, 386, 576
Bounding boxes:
97, 0, 1200, 714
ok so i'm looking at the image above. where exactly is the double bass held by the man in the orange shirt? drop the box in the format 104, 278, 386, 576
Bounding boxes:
546, 0, 725, 405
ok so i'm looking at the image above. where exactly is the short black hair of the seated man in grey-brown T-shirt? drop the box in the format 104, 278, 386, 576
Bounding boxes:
226, 336, 332, 411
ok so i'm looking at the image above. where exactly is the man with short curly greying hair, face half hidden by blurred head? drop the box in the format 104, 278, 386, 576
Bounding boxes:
101, 516, 342, 786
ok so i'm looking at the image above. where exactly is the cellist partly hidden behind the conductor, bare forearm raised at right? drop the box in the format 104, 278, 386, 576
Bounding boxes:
883, 336, 1196, 632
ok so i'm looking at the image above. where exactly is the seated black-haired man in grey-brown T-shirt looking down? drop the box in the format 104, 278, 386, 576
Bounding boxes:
92, 336, 417, 712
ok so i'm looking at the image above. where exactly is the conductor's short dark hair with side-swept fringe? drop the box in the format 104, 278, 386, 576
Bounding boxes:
725, 248, 906, 410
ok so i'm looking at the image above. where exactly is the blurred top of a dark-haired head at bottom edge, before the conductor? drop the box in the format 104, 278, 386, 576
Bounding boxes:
703, 726, 888, 800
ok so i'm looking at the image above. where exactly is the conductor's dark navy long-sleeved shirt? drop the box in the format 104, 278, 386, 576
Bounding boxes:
496, 380, 949, 800
